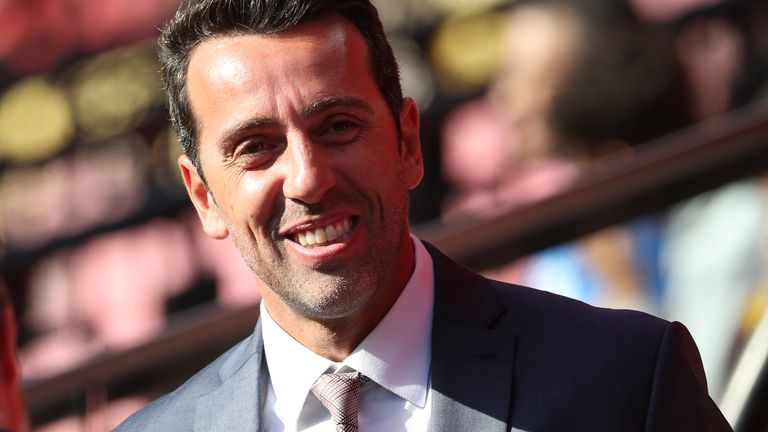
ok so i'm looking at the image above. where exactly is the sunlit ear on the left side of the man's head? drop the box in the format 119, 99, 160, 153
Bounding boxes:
178, 155, 229, 240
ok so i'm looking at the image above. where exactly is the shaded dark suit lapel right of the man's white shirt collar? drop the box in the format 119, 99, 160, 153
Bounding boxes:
428, 247, 514, 432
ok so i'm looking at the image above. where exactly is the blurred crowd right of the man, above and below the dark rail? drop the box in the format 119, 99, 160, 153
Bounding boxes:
441, 0, 768, 397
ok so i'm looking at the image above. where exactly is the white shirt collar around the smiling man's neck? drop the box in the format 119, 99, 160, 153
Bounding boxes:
261, 236, 434, 418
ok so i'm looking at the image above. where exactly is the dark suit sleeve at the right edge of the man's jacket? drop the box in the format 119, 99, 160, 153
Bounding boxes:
645, 322, 733, 432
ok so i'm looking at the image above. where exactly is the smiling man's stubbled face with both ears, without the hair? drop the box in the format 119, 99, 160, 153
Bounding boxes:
180, 17, 422, 319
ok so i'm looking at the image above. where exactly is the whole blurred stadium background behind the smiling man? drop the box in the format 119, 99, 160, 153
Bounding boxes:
0, 0, 768, 432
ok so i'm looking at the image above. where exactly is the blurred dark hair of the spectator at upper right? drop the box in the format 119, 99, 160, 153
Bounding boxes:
549, 3, 689, 149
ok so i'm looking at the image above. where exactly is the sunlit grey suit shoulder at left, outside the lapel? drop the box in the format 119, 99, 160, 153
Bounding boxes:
115, 332, 261, 432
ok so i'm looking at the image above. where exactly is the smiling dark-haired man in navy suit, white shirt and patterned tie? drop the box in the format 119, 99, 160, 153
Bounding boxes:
118, 0, 730, 431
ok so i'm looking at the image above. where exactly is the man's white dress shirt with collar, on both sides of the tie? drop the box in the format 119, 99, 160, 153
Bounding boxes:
261, 236, 434, 432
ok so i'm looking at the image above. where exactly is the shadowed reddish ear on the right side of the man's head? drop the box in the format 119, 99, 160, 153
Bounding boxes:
400, 97, 424, 189
